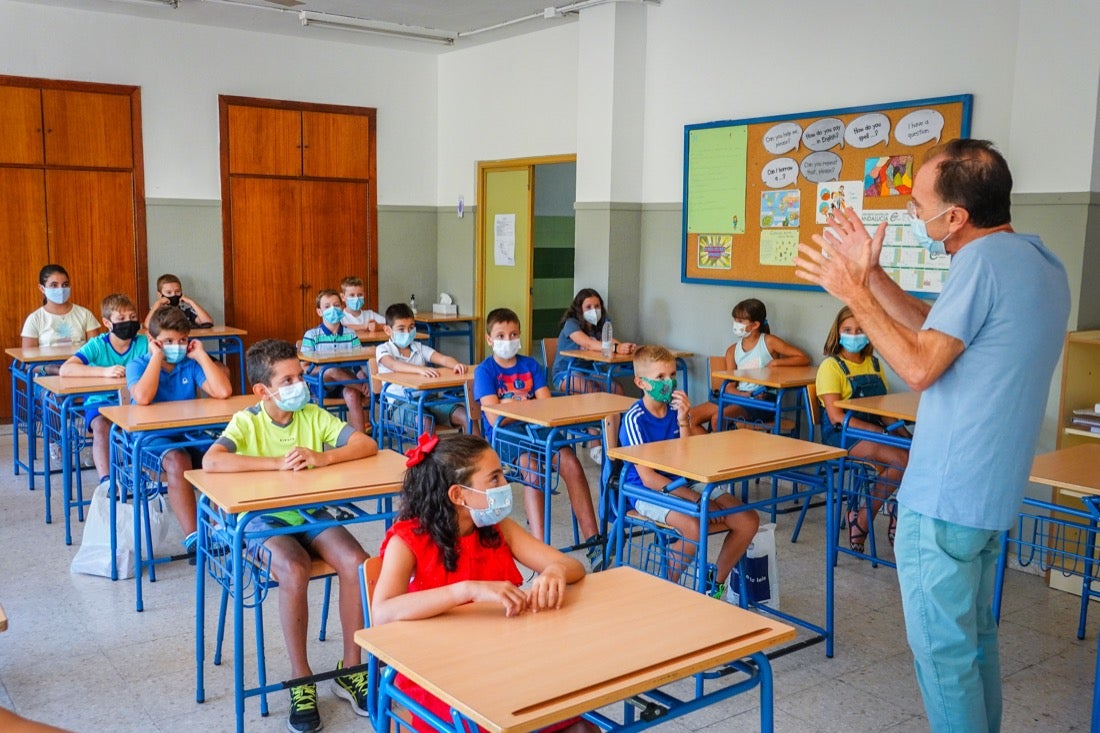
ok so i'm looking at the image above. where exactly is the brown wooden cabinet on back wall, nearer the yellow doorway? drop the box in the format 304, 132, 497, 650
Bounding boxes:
220, 97, 377, 341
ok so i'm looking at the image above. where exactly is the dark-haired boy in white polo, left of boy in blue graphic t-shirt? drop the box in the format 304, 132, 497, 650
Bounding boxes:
374, 303, 466, 433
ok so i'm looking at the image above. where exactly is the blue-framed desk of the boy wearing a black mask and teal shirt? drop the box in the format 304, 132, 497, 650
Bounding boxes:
34, 376, 127, 545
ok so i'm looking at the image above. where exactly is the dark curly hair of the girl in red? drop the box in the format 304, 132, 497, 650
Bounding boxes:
397, 434, 502, 572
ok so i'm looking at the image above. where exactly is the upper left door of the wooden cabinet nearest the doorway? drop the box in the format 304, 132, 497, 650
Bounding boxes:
228, 105, 301, 176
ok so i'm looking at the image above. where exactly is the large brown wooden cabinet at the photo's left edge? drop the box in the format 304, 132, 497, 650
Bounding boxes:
0, 76, 149, 419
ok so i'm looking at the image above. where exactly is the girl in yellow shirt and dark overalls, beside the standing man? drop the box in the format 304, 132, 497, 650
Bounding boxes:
817, 306, 910, 553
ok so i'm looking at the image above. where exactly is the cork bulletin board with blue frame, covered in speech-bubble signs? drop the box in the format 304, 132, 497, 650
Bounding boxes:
681, 95, 974, 296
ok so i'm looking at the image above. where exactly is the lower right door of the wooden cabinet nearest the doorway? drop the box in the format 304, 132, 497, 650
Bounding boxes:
301, 180, 372, 322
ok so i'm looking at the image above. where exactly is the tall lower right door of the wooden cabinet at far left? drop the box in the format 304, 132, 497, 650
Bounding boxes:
46, 171, 138, 308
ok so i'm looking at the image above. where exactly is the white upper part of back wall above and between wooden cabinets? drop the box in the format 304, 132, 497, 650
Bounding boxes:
0, 0, 437, 205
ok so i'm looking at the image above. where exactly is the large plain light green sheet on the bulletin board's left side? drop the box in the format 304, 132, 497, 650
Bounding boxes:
686, 124, 749, 234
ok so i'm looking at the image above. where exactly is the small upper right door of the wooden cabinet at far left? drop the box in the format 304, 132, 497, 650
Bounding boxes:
42, 89, 133, 168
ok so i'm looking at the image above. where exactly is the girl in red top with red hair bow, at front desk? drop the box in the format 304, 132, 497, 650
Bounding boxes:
371, 435, 597, 732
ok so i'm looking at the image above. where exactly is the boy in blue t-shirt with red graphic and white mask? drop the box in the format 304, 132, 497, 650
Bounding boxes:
474, 308, 603, 570
